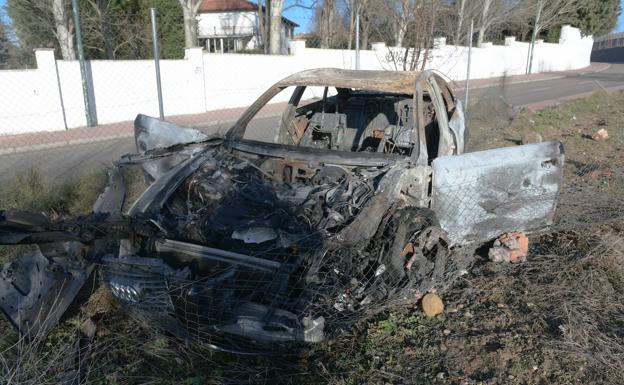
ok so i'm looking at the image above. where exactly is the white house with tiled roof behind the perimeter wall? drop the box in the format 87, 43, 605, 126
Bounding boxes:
197, 0, 298, 53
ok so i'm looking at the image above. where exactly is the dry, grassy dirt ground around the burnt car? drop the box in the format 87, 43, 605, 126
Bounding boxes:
0, 93, 624, 385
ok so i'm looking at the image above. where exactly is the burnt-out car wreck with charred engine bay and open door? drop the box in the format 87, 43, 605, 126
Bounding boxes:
0, 69, 564, 353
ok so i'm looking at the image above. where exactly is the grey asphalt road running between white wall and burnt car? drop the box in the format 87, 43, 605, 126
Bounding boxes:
0, 57, 624, 181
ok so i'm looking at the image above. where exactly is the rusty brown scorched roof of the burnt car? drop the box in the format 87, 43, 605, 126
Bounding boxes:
277, 68, 429, 95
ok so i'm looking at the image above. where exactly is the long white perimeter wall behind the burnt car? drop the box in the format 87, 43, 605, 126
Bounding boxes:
0, 26, 593, 134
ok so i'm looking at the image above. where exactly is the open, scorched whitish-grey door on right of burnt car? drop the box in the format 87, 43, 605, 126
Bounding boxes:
432, 141, 564, 244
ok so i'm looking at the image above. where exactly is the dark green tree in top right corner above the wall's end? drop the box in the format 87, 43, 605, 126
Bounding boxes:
570, 0, 622, 36
